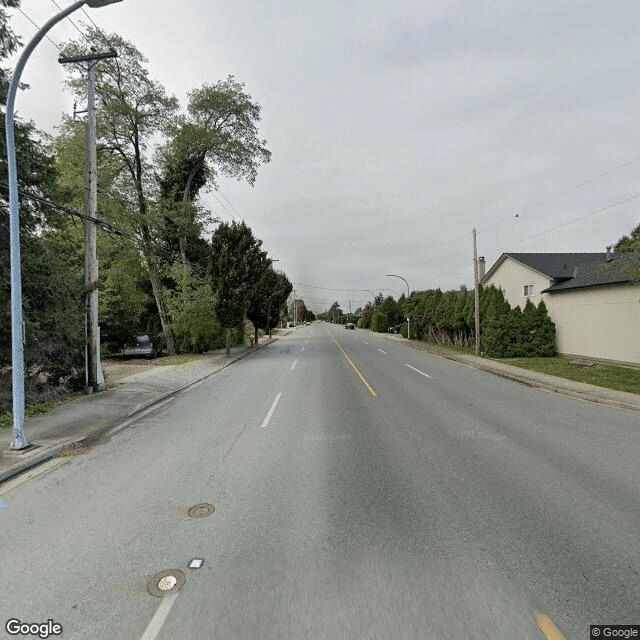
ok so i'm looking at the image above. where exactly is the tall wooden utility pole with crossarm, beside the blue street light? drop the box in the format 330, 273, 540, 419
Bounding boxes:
58, 49, 118, 393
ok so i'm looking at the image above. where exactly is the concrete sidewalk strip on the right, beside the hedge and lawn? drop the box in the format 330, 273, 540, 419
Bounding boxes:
370, 329, 640, 411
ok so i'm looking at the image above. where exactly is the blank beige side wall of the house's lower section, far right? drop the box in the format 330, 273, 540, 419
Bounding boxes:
543, 283, 640, 364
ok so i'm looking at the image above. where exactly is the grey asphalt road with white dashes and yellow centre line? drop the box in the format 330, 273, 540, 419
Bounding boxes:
0, 323, 640, 640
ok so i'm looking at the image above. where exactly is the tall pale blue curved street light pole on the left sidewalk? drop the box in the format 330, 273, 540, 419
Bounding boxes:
5, 0, 122, 449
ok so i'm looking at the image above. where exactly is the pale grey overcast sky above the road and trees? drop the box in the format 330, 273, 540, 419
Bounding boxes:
8, 0, 640, 312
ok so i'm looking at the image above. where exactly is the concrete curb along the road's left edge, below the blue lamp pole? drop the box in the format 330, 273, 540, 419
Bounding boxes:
0, 336, 281, 484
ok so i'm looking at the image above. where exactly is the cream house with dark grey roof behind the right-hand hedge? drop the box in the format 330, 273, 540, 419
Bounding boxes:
481, 249, 640, 365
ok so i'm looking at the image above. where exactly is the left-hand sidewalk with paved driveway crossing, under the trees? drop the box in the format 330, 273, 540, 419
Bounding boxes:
0, 338, 290, 482
